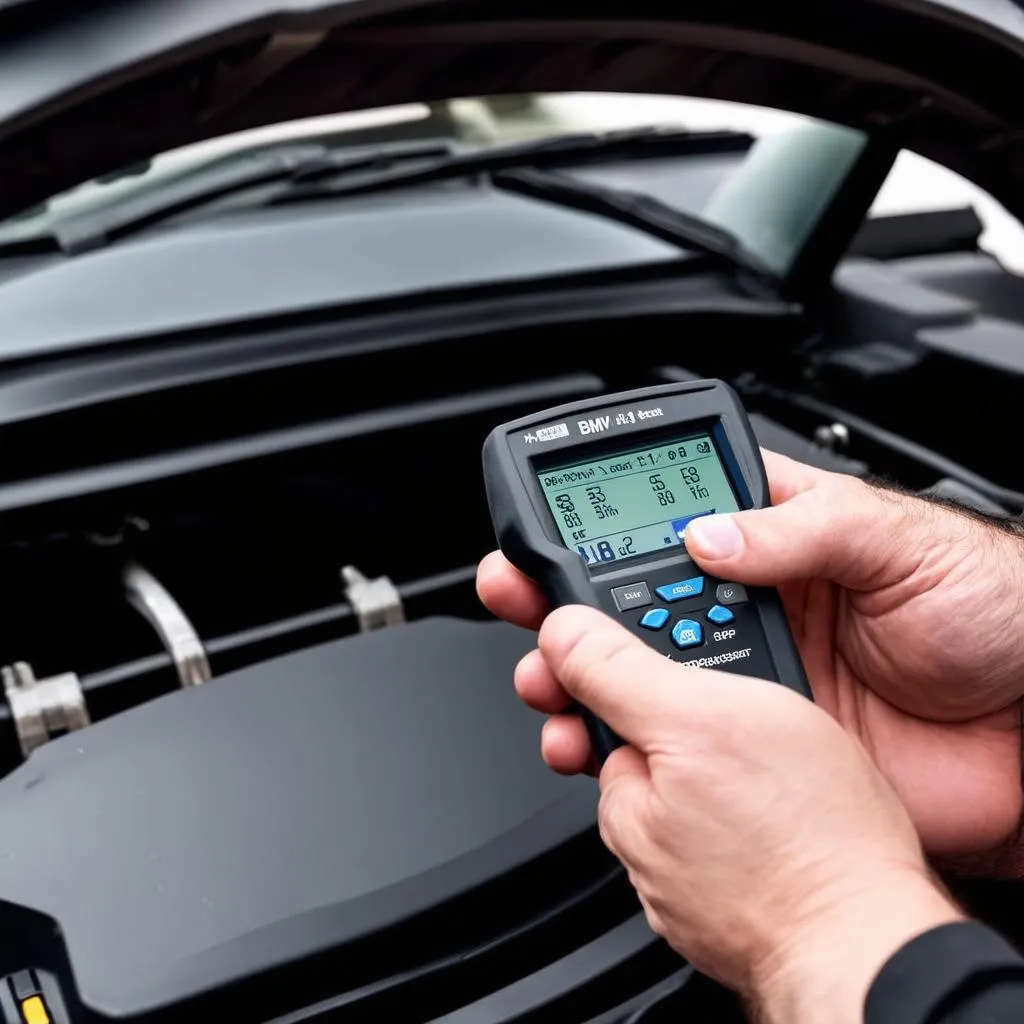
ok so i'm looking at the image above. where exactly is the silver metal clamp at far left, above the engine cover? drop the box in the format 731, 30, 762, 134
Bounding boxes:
0, 662, 90, 758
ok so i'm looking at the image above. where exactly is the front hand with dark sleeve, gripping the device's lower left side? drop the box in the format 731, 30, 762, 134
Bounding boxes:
517, 607, 959, 1024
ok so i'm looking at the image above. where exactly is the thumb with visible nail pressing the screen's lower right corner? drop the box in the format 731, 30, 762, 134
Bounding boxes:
686, 475, 922, 590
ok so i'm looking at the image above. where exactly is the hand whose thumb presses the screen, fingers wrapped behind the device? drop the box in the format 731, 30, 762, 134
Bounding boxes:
477, 453, 1024, 856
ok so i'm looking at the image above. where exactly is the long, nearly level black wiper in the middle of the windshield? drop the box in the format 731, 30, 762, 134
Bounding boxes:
266, 127, 753, 206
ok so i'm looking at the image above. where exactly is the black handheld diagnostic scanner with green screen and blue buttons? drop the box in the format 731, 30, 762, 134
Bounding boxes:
483, 380, 811, 761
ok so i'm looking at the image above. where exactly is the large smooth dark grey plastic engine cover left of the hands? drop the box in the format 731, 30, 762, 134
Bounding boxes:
0, 618, 596, 1017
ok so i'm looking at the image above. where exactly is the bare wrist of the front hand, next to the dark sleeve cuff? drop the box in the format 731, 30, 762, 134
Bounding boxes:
746, 868, 965, 1024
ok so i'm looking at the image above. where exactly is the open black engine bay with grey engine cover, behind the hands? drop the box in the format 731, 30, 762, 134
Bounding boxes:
0, 220, 1024, 1022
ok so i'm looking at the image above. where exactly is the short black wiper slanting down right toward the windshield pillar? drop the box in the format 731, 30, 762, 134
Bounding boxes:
490, 168, 771, 280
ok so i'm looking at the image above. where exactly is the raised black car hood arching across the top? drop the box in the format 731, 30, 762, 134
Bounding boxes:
0, 0, 1024, 224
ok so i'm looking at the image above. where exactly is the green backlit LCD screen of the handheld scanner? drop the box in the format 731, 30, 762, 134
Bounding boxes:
537, 434, 739, 564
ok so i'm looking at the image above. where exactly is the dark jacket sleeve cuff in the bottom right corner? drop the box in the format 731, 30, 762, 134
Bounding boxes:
864, 922, 1024, 1024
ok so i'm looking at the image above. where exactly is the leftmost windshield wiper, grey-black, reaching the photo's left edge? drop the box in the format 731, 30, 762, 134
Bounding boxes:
0, 142, 451, 256
